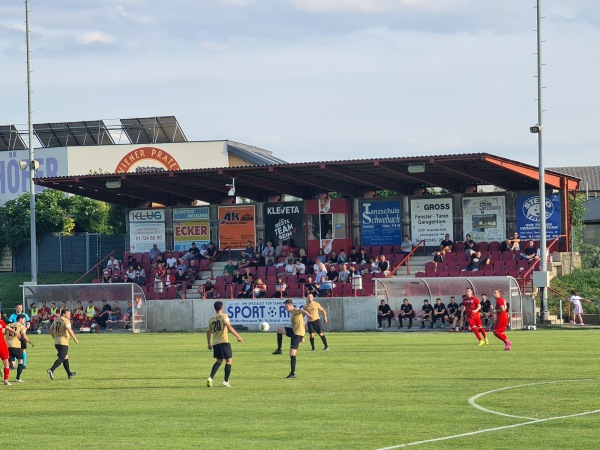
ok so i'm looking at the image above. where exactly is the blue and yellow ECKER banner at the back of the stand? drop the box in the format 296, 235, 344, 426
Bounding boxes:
173, 206, 210, 251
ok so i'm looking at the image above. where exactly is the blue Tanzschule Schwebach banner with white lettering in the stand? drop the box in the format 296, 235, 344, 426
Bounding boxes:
360, 200, 402, 246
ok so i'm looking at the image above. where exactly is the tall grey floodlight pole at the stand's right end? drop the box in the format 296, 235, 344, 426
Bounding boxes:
536, 0, 548, 321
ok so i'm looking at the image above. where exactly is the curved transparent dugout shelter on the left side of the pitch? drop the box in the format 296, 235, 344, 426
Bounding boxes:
20, 283, 148, 333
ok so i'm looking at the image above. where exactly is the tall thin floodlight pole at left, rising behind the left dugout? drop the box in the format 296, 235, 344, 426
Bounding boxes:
25, 0, 37, 284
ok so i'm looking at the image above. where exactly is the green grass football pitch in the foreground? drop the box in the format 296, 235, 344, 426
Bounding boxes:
0, 329, 600, 449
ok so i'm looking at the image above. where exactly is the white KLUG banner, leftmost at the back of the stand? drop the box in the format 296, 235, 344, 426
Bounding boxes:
128, 209, 165, 253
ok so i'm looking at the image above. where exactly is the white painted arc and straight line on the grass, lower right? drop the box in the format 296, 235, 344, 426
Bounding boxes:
378, 378, 600, 450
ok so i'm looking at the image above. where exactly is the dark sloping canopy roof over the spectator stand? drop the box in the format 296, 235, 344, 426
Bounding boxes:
35, 153, 579, 208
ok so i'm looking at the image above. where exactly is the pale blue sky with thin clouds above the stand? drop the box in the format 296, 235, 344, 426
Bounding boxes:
0, 0, 600, 167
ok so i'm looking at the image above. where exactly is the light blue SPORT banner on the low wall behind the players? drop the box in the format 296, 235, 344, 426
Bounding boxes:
223, 300, 305, 329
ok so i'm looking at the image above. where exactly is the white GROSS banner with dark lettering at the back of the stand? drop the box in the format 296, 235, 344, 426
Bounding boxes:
410, 197, 454, 247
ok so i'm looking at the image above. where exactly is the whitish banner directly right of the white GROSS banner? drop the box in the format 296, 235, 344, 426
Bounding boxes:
462, 195, 506, 242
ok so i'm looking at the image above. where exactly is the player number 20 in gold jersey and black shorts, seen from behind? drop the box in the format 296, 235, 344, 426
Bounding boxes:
206, 301, 243, 387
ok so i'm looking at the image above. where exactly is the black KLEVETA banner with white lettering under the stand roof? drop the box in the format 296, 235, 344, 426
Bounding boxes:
264, 202, 306, 247
